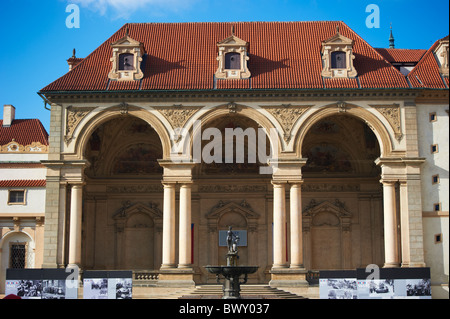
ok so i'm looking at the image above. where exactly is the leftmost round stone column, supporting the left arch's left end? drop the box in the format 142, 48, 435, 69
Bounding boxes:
69, 184, 83, 267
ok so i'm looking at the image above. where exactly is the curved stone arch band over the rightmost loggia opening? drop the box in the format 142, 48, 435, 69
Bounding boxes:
295, 102, 395, 158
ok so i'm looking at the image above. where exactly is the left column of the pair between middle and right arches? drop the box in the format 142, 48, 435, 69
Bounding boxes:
272, 182, 286, 268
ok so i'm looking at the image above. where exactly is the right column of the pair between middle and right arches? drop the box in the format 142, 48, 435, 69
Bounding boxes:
290, 183, 304, 269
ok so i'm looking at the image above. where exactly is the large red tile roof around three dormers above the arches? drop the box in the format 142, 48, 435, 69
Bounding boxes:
41, 21, 420, 93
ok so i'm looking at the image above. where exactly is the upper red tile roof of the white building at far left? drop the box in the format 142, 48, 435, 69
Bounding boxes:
0, 119, 49, 146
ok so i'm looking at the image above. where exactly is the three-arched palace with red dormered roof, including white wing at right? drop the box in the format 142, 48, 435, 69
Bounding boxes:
30, 22, 449, 297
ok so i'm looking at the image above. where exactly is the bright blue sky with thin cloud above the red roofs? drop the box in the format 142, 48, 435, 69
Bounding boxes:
0, 0, 449, 130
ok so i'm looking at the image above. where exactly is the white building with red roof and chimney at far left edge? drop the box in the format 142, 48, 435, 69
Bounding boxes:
0, 105, 48, 292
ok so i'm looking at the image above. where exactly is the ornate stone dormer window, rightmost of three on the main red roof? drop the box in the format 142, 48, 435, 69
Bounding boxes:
322, 27, 358, 78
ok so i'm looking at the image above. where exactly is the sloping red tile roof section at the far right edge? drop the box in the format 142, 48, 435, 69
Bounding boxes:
408, 36, 449, 89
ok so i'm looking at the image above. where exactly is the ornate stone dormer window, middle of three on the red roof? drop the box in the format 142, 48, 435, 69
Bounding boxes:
215, 29, 251, 79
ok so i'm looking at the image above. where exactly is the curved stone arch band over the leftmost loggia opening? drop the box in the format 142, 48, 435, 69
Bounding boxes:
74, 106, 171, 159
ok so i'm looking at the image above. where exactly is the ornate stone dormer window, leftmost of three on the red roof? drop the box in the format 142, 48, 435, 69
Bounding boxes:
108, 30, 145, 81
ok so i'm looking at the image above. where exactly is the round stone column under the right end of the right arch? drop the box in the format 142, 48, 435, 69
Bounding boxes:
381, 180, 399, 267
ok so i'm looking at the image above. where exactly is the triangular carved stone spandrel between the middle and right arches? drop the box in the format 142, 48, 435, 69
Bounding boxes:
263, 104, 312, 142
